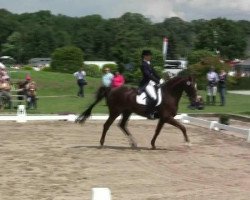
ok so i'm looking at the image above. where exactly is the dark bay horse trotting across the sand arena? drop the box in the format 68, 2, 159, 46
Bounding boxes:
76, 77, 197, 149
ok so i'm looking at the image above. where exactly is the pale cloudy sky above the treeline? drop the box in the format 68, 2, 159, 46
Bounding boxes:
0, 0, 250, 22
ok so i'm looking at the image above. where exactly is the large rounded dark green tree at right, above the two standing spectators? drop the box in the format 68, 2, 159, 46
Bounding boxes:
194, 18, 247, 59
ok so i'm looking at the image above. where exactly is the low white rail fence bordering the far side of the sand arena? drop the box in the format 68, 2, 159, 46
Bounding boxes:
0, 107, 250, 142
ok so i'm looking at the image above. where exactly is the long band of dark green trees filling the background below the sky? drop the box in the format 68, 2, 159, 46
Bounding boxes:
0, 9, 250, 81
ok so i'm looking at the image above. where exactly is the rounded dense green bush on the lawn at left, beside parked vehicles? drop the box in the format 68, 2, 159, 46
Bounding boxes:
51, 46, 83, 73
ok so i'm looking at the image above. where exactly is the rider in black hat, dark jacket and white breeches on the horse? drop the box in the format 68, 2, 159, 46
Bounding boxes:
140, 50, 160, 119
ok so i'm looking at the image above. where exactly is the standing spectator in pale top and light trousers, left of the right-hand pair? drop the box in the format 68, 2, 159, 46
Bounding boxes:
207, 66, 219, 105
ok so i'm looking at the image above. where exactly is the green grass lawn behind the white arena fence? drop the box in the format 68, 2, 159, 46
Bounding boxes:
2, 71, 250, 115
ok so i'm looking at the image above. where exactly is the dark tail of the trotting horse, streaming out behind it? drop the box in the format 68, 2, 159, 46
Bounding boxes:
75, 86, 110, 123
